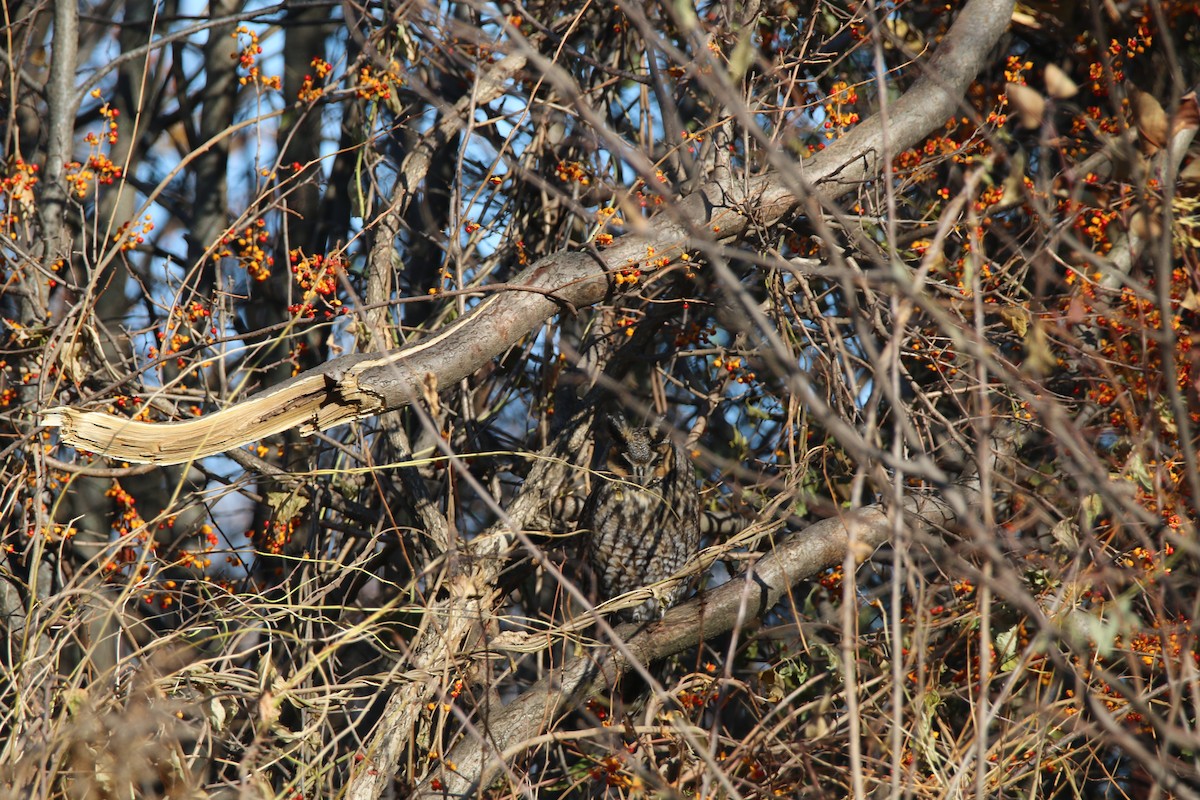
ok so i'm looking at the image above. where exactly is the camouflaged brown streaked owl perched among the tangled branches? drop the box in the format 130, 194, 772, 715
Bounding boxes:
581, 413, 700, 622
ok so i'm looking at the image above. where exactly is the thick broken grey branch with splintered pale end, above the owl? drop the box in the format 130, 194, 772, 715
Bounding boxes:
43, 0, 1013, 464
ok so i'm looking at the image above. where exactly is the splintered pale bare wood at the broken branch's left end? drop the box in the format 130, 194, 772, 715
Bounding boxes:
42, 374, 371, 464
